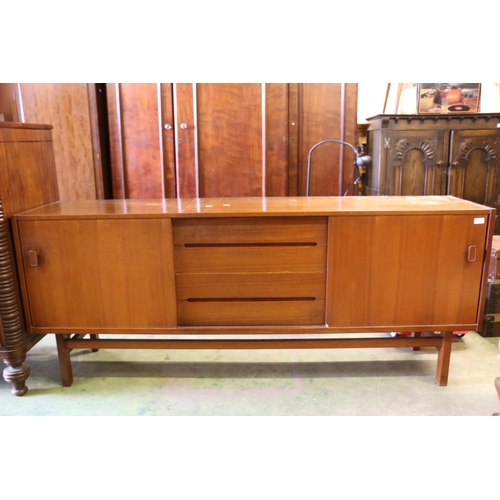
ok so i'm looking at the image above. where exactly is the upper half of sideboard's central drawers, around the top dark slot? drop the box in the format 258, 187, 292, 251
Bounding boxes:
174, 217, 327, 273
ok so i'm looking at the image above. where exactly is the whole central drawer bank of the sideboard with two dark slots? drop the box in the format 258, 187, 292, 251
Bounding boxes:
174, 217, 327, 326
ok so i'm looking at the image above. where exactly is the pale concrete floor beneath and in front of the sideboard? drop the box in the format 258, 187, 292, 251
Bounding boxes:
0, 332, 500, 416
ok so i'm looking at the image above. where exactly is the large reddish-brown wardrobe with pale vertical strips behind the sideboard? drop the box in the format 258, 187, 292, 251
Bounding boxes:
106, 83, 357, 199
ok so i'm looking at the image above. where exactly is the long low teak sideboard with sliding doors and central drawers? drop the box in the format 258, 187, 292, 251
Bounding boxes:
12, 196, 495, 386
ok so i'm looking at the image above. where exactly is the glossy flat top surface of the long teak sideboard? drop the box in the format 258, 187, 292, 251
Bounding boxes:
16, 196, 492, 220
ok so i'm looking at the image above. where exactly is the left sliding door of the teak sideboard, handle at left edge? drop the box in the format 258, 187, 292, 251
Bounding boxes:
19, 219, 176, 331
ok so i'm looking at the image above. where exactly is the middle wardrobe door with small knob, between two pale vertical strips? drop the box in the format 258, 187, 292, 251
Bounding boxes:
173, 83, 288, 197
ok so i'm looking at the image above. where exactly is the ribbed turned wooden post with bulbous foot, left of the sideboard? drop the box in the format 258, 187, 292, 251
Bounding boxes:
0, 198, 30, 396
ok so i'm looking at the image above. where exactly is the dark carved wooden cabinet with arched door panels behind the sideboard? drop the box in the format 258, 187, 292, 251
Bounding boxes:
365, 114, 500, 230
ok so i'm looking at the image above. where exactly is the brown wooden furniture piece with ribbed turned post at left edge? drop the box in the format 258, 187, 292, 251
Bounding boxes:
0, 122, 59, 396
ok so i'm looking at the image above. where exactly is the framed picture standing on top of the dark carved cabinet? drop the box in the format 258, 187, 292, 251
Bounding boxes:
417, 83, 481, 114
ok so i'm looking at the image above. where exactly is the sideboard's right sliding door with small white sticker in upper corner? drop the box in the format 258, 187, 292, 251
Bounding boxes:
327, 214, 488, 330
